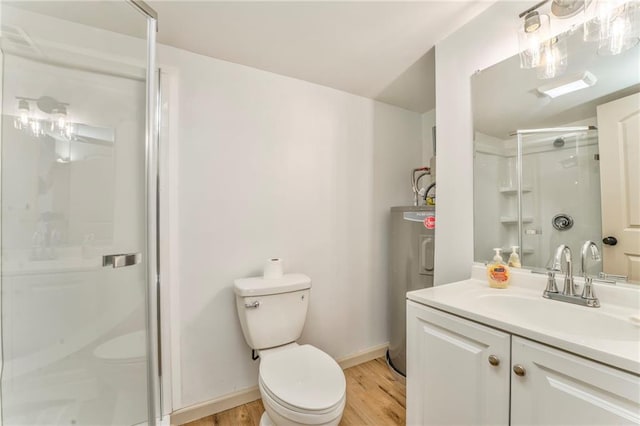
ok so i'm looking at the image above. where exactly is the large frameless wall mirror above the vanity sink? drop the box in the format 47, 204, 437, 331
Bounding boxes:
471, 22, 640, 282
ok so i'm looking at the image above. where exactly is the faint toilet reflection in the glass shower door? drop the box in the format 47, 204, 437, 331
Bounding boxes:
93, 330, 147, 424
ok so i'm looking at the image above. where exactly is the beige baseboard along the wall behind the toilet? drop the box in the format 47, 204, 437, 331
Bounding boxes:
171, 343, 389, 425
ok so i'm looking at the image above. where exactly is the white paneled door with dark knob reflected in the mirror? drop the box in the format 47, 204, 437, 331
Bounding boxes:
598, 93, 640, 282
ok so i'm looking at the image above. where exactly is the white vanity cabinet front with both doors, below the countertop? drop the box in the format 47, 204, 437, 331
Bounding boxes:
407, 301, 640, 425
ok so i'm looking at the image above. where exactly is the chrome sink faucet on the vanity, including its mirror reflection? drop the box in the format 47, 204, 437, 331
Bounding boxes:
542, 241, 600, 308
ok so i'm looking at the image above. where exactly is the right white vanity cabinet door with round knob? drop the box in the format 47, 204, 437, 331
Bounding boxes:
511, 337, 640, 426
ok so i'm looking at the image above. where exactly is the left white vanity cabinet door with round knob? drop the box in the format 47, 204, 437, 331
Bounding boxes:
407, 301, 510, 425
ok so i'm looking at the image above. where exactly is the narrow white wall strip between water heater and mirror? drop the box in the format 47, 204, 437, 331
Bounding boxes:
434, 2, 531, 285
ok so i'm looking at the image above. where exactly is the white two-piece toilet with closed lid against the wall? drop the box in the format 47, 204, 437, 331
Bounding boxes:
234, 274, 346, 426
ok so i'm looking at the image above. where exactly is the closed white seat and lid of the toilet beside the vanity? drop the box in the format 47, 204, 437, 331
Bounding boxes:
259, 345, 346, 417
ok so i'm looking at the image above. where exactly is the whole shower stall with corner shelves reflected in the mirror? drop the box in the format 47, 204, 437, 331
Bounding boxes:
474, 126, 602, 272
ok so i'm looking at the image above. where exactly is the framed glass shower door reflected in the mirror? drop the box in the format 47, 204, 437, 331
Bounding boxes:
519, 128, 601, 275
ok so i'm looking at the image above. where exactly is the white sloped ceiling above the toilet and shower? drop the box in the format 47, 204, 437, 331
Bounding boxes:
6, 0, 493, 113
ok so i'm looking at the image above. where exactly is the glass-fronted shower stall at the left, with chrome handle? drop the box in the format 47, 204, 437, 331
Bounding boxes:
0, 1, 161, 425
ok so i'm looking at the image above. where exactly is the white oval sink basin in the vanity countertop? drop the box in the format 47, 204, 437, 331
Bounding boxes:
474, 294, 640, 341
